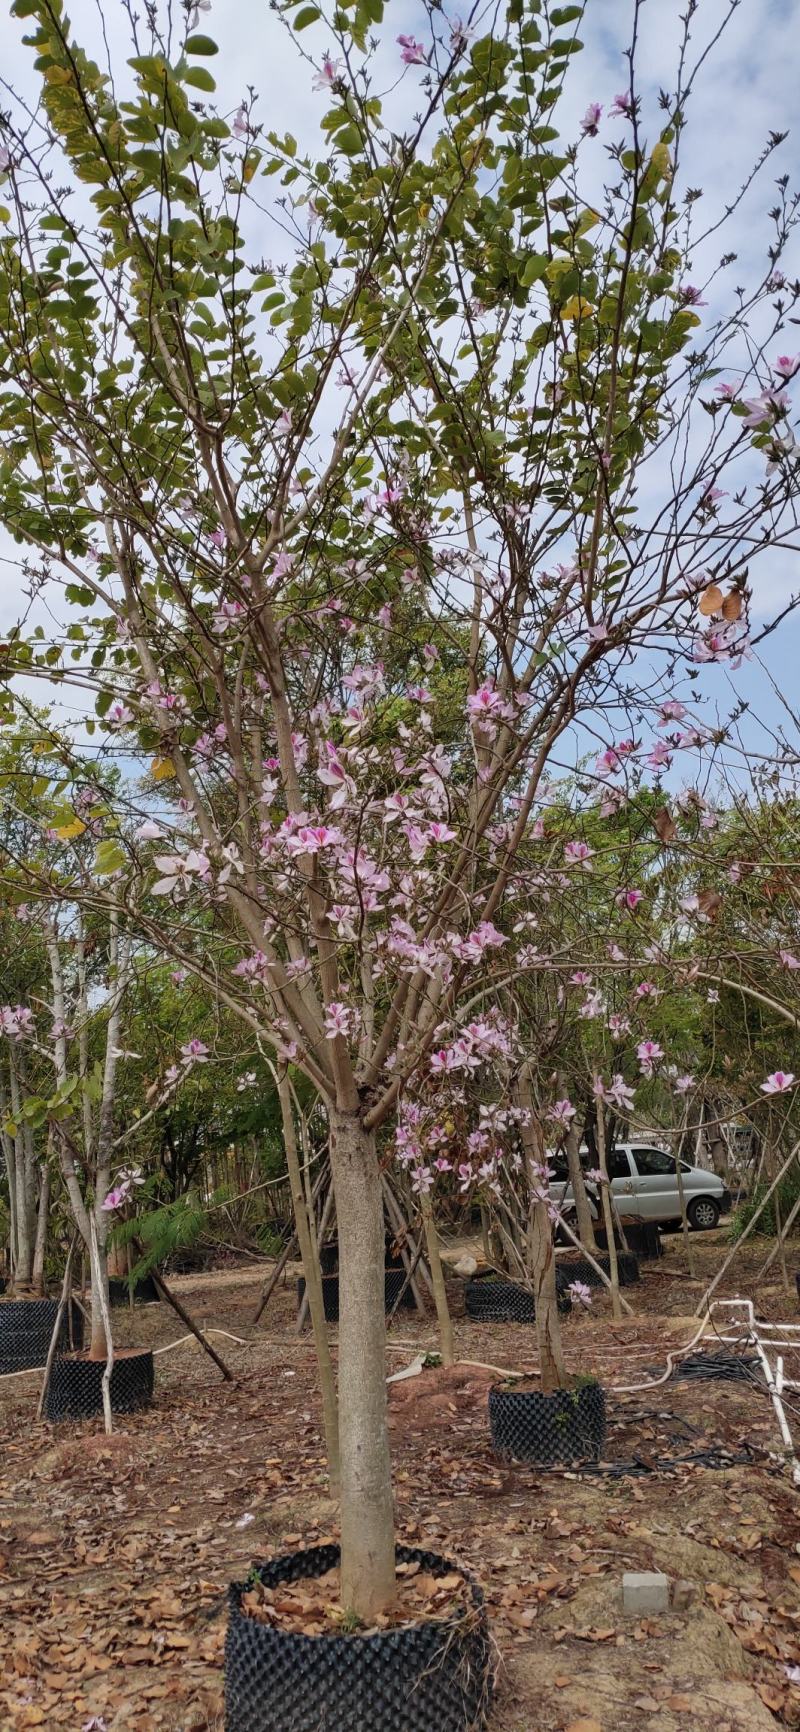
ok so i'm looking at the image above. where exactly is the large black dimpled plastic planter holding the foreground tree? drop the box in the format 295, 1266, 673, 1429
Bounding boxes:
225, 1545, 492, 1732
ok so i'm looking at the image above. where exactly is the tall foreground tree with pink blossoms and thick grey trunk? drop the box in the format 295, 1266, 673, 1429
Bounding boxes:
0, 0, 795, 1616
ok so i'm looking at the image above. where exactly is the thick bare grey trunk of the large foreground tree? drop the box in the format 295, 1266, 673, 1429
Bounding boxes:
331, 1107, 395, 1621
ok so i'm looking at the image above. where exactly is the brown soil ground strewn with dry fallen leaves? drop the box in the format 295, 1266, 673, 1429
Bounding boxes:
0, 1235, 800, 1732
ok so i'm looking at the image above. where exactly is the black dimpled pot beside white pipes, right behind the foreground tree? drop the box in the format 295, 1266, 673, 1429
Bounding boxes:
488, 1382, 606, 1465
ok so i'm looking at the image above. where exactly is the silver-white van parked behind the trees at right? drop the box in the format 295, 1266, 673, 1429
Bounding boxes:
547, 1143, 731, 1231
